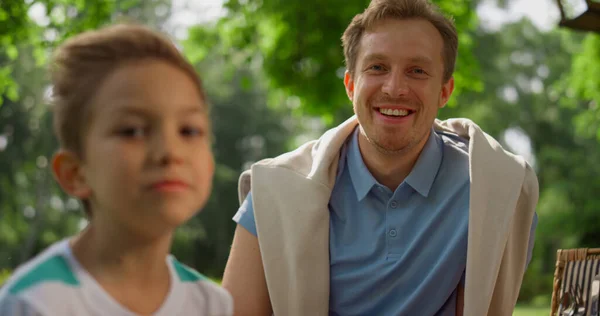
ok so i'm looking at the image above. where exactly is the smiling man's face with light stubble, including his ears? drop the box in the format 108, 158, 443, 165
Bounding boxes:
344, 19, 454, 153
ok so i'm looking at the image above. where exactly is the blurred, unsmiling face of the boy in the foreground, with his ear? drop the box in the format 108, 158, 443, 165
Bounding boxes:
54, 60, 214, 235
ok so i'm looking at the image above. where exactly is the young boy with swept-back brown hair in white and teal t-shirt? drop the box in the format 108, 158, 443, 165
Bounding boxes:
0, 25, 233, 316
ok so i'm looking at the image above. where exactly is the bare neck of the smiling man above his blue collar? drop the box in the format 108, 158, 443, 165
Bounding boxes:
358, 133, 429, 191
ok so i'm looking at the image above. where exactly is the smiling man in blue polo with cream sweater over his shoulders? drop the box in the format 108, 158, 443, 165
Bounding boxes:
223, 0, 538, 316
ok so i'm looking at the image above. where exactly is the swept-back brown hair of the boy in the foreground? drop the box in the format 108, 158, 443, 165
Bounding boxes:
50, 24, 208, 217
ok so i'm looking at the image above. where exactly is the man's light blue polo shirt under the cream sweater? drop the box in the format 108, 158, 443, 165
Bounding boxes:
234, 129, 537, 316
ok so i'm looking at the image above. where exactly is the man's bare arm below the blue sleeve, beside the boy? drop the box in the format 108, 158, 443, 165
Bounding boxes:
223, 225, 273, 316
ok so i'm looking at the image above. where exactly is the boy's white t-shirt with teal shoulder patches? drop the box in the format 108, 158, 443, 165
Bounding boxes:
0, 240, 233, 316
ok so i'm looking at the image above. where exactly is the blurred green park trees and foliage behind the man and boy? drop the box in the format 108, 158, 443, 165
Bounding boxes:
0, 0, 600, 315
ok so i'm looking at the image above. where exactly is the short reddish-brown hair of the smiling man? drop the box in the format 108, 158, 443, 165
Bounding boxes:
342, 0, 458, 82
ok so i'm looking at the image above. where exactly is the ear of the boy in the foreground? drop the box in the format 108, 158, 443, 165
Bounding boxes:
52, 150, 92, 199
